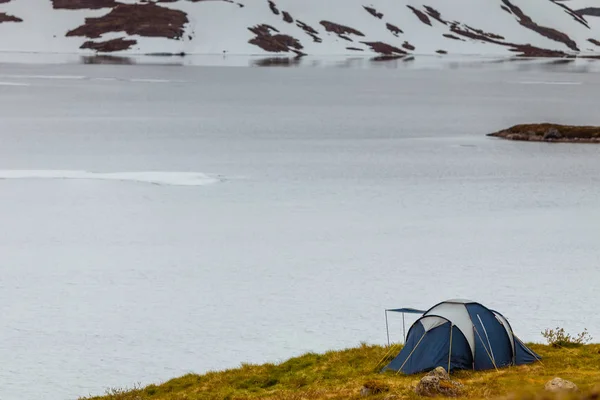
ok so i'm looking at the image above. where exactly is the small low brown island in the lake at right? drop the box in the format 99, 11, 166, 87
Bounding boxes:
487, 123, 600, 143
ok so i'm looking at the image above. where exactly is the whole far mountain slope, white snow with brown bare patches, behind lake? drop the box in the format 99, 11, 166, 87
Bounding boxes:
0, 0, 600, 57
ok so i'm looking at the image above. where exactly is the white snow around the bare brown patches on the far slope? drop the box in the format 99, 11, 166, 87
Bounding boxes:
0, 0, 600, 55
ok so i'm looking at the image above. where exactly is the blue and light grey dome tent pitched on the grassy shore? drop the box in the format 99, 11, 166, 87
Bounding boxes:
383, 300, 541, 374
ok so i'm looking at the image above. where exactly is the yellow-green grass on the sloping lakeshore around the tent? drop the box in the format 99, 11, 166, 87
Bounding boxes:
81, 344, 600, 400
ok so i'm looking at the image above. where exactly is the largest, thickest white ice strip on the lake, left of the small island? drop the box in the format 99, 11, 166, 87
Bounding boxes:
0, 170, 223, 186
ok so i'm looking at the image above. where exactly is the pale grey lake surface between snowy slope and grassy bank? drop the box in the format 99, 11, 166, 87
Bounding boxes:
0, 60, 600, 400
